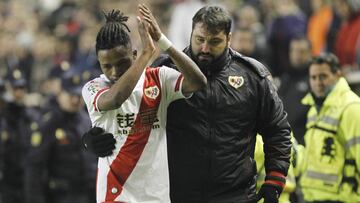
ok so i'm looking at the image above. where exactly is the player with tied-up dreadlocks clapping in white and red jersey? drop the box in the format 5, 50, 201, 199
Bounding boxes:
82, 5, 207, 203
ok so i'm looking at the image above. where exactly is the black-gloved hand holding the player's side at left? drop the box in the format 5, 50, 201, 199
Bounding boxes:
82, 127, 116, 157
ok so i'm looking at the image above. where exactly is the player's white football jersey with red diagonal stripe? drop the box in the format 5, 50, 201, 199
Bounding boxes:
82, 66, 185, 203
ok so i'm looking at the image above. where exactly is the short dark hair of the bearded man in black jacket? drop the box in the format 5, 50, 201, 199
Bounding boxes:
192, 6, 232, 35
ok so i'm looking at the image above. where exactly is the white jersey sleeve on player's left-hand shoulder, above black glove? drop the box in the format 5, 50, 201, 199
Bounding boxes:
82, 79, 110, 118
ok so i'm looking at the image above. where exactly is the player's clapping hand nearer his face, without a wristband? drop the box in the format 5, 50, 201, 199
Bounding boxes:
137, 16, 155, 54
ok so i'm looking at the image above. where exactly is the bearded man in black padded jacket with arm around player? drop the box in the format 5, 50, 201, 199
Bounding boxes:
83, 6, 291, 203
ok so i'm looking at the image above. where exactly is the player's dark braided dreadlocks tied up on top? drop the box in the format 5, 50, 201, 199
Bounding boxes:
96, 10, 131, 54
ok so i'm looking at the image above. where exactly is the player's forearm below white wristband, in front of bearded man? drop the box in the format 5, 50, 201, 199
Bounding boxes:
166, 46, 207, 93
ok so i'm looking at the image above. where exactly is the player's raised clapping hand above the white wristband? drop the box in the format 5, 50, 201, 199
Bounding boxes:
138, 4, 161, 41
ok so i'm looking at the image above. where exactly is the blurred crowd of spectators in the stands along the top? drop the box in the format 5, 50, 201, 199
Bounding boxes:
0, 0, 360, 94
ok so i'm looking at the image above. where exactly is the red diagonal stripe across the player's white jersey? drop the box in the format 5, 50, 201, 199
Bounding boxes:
105, 68, 161, 201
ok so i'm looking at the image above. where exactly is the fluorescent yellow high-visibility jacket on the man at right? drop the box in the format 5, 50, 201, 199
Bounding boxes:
300, 78, 360, 202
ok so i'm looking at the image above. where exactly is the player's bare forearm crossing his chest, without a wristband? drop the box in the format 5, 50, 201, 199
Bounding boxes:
98, 51, 153, 111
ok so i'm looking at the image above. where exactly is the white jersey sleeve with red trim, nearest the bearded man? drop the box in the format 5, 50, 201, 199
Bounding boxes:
159, 66, 192, 103
